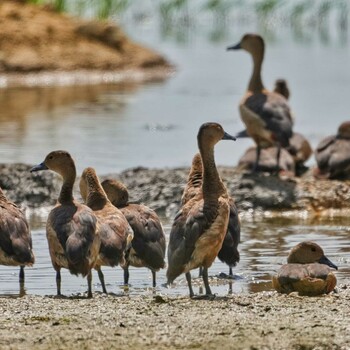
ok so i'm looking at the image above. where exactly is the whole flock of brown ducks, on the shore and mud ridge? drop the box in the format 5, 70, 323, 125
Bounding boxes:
0, 34, 342, 298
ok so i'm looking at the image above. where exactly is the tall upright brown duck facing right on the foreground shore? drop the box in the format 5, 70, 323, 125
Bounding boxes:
167, 123, 235, 297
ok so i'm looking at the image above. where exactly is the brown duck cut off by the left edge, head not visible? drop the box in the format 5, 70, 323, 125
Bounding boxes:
0, 188, 35, 283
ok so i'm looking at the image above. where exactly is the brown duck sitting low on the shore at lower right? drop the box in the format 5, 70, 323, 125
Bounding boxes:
272, 241, 338, 295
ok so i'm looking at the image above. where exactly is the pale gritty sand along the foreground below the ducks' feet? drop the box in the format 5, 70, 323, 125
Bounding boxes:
0, 286, 350, 350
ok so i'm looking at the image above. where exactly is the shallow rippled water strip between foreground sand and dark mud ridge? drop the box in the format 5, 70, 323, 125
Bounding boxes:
0, 218, 350, 296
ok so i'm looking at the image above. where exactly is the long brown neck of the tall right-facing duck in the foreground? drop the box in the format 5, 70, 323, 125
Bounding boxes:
199, 145, 225, 205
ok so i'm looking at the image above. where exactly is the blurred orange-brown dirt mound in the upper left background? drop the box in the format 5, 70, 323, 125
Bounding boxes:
0, 1, 169, 73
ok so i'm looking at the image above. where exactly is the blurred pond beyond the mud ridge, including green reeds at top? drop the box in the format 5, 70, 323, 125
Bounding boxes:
0, 0, 350, 174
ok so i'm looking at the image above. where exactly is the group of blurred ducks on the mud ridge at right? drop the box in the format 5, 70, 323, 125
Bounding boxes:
227, 34, 350, 179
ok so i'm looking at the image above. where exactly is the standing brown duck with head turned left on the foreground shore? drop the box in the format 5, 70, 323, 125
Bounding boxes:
30, 151, 100, 298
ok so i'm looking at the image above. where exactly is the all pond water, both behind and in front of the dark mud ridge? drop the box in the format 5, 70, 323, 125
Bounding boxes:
0, 4, 350, 295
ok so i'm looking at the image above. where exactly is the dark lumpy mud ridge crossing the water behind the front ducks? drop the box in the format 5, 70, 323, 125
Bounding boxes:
0, 164, 350, 218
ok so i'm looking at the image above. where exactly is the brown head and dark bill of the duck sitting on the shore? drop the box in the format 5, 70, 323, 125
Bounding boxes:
287, 241, 338, 270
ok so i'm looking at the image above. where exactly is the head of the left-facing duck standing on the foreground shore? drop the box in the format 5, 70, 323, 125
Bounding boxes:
30, 150, 75, 177
